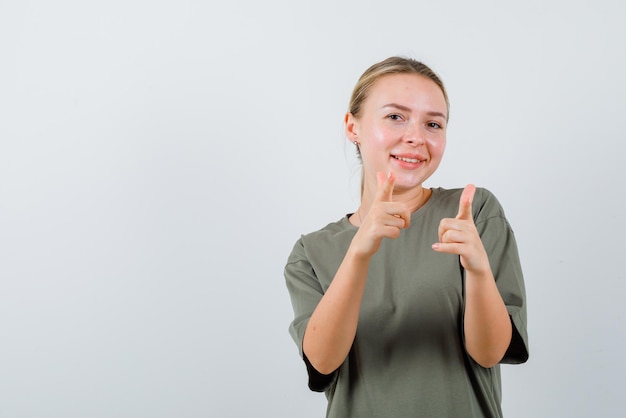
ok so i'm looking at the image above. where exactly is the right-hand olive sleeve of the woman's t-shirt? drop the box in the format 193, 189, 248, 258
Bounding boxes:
474, 189, 529, 364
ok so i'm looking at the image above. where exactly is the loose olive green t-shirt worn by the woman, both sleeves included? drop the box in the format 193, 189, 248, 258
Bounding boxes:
285, 188, 528, 418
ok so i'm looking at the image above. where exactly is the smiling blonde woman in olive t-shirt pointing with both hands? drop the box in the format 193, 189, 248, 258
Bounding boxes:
285, 57, 528, 418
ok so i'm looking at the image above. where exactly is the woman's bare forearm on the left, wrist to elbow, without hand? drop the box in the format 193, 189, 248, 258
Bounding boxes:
302, 251, 369, 374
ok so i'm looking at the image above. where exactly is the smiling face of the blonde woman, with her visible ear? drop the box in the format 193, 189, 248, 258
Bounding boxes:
346, 74, 447, 191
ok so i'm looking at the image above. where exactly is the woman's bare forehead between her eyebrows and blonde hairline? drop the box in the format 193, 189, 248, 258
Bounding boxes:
366, 73, 447, 114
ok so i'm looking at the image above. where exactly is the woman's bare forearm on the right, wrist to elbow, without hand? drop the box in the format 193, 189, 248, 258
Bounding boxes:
464, 270, 512, 368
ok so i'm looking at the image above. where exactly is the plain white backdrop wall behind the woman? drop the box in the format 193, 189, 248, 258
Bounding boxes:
0, 0, 626, 418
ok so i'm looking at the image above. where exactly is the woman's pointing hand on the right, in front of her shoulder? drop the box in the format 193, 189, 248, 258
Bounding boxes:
433, 184, 491, 273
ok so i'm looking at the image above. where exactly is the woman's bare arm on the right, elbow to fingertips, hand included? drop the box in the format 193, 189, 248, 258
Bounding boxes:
433, 185, 512, 368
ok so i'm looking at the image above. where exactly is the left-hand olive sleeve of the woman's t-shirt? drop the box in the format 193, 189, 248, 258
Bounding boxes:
285, 238, 337, 392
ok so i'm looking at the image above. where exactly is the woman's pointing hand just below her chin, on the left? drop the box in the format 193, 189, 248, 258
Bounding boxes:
352, 172, 411, 256
